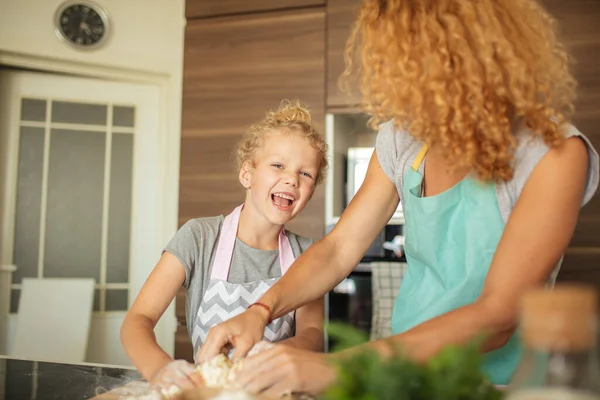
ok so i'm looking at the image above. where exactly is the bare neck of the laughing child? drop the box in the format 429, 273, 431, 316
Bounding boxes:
237, 203, 282, 250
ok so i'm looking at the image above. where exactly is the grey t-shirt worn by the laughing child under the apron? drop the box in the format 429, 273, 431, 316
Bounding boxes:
164, 215, 314, 337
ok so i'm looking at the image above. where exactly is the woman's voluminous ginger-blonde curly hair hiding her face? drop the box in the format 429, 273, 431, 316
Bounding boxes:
340, 0, 576, 181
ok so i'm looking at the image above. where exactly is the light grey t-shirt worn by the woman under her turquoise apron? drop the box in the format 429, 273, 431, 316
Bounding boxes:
375, 120, 598, 224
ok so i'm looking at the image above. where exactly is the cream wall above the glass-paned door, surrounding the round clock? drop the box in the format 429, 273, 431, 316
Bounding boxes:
0, 0, 185, 75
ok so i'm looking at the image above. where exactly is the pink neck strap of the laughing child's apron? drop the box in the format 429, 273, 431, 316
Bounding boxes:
210, 204, 295, 281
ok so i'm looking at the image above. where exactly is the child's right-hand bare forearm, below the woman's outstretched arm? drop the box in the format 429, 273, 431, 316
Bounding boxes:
279, 297, 325, 351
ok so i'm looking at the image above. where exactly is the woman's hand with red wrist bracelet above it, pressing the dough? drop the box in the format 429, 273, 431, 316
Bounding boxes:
196, 307, 269, 363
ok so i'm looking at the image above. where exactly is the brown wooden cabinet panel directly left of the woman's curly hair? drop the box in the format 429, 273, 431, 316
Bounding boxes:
327, 0, 361, 109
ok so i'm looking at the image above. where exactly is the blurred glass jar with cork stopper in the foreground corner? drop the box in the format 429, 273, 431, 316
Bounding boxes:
507, 284, 600, 400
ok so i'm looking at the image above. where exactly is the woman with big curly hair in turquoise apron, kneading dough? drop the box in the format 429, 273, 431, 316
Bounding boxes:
201, 0, 598, 393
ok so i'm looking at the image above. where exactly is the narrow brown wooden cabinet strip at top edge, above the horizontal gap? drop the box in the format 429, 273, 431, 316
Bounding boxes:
185, 0, 325, 19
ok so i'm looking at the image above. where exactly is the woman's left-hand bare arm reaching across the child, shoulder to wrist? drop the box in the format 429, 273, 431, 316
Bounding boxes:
260, 152, 400, 318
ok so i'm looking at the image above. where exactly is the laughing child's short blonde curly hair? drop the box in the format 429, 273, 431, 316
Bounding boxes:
236, 100, 329, 184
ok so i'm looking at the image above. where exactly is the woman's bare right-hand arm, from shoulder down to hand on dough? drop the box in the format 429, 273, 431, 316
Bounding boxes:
234, 139, 588, 395
